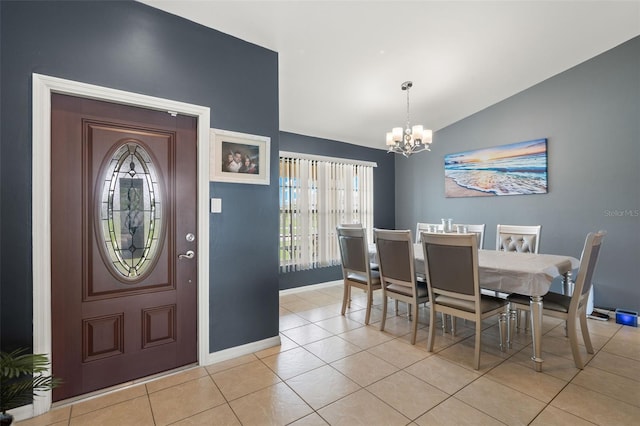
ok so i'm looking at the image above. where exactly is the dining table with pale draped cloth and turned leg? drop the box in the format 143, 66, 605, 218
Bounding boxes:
368, 243, 580, 371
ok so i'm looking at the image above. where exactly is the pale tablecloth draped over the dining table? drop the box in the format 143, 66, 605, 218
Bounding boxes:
369, 244, 580, 296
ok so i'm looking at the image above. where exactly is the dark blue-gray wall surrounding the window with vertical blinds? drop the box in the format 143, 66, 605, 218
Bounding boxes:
280, 132, 395, 290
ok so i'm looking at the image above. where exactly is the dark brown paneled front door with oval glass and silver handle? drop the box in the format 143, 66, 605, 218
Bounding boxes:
51, 94, 198, 401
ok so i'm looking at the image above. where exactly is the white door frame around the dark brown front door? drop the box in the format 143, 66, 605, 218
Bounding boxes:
31, 73, 210, 416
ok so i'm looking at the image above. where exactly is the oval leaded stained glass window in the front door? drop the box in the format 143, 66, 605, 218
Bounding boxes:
100, 141, 163, 281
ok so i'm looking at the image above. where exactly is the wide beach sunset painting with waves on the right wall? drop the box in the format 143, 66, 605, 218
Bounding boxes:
444, 139, 547, 197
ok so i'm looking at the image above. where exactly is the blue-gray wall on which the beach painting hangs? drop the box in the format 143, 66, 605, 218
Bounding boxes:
396, 37, 640, 310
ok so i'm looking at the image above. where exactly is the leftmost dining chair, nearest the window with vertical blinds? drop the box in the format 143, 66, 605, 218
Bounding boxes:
336, 226, 381, 324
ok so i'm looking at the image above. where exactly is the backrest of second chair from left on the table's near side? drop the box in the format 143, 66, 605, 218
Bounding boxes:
373, 229, 416, 291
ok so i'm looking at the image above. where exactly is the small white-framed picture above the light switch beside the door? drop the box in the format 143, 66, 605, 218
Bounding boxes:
209, 129, 271, 185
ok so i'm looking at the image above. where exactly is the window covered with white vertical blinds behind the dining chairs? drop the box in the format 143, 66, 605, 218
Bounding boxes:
279, 152, 375, 272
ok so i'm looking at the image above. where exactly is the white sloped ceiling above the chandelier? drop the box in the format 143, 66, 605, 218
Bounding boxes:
141, 0, 640, 149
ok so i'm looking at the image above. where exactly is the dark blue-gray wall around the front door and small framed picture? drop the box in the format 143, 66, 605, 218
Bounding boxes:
0, 1, 279, 352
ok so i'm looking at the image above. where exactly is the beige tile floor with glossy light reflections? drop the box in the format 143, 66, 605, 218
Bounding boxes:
19, 284, 640, 426
